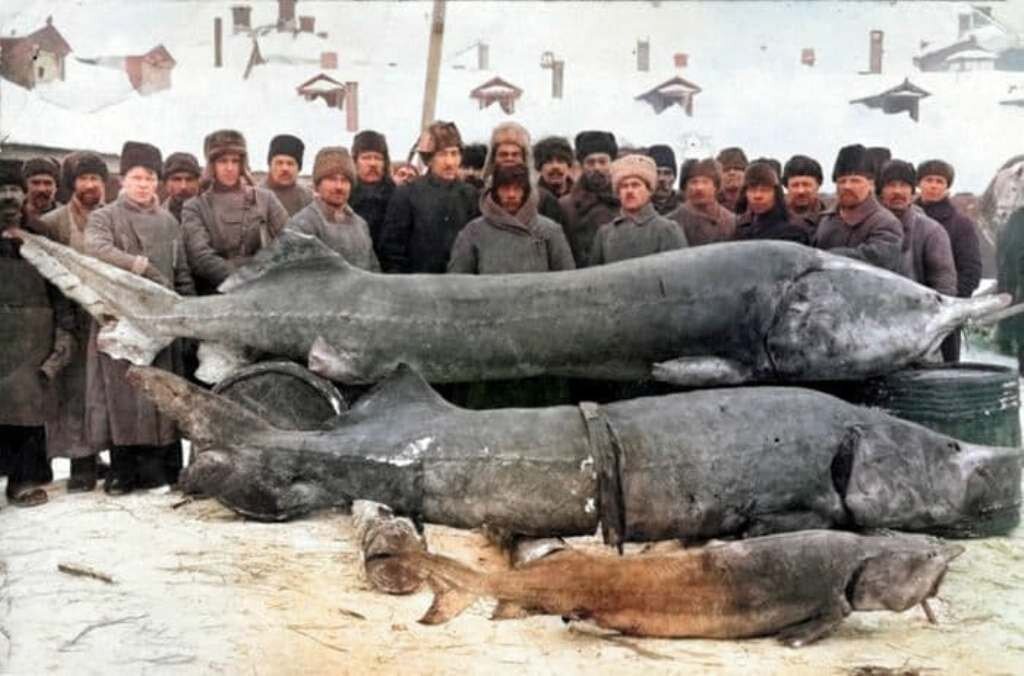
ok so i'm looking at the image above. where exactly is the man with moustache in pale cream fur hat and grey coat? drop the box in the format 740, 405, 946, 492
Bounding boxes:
590, 155, 686, 265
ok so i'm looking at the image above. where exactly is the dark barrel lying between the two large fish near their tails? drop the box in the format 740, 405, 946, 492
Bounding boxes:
213, 361, 348, 430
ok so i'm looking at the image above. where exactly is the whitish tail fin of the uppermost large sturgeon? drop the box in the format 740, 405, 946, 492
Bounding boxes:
18, 233, 182, 364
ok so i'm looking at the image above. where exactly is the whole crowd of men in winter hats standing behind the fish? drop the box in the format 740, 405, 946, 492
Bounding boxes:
0, 122, 981, 506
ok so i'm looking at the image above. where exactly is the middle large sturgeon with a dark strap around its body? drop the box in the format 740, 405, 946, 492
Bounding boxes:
128, 367, 1021, 544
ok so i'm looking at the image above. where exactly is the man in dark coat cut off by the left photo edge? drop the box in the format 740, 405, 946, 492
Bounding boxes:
0, 161, 74, 507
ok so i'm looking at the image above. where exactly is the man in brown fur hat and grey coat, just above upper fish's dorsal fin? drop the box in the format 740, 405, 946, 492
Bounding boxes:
288, 146, 381, 272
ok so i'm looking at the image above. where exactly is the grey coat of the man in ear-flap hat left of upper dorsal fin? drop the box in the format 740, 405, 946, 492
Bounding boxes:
181, 183, 288, 293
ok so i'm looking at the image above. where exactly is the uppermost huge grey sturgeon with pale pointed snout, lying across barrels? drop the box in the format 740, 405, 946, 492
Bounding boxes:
12, 230, 1010, 387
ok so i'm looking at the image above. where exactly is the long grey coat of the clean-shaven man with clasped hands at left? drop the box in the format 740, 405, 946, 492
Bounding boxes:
85, 195, 196, 449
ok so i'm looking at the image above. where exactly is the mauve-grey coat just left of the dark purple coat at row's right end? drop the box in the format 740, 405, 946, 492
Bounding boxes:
897, 205, 956, 296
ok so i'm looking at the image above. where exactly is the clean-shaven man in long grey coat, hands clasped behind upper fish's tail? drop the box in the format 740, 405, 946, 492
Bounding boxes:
85, 141, 196, 495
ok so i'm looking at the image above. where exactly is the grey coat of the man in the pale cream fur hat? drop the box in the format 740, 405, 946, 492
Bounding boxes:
590, 203, 686, 265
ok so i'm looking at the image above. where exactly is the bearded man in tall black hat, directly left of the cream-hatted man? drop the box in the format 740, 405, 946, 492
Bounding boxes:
558, 131, 621, 267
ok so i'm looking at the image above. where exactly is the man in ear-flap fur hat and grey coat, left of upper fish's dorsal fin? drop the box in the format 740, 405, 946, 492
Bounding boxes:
181, 129, 288, 294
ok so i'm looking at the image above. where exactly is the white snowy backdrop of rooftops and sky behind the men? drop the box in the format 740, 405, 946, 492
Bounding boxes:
0, 0, 1024, 193
